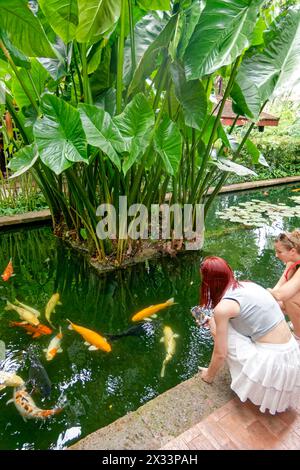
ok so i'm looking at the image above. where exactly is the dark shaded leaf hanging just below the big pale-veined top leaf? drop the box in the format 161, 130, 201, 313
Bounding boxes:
171, 62, 207, 130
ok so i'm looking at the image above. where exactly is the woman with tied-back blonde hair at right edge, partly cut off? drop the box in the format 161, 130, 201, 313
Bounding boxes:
268, 230, 300, 346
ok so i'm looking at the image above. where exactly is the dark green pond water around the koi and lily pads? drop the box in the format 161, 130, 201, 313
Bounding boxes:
0, 181, 300, 449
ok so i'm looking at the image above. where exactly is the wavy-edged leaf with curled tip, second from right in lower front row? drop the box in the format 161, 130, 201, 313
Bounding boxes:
113, 93, 154, 175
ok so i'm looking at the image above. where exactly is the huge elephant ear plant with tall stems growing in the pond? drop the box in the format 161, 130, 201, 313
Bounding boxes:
0, 0, 300, 264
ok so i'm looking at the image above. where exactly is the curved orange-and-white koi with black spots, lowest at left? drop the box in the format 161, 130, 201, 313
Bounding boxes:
6, 386, 63, 421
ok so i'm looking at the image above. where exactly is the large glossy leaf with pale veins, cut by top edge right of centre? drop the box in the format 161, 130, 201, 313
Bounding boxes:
184, 0, 265, 80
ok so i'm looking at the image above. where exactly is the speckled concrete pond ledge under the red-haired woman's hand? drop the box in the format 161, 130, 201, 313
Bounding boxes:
68, 369, 234, 450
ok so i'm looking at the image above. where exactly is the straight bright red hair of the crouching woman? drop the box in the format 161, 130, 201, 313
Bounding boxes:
200, 256, 239, 308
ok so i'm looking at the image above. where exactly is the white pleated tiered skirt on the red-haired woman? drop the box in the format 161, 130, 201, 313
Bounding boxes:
227, 324, 300, 414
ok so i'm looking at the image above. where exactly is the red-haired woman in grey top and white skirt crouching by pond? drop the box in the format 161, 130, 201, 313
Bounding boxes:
200, 256, 300, 414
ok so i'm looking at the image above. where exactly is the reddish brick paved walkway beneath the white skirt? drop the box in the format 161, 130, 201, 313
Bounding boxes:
161, 398, 300, 450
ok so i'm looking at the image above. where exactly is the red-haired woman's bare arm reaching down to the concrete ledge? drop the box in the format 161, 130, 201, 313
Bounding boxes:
201, 300, 240, 383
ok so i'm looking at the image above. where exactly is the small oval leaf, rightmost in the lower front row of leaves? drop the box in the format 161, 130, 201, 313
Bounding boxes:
154, 116, 182, 176
